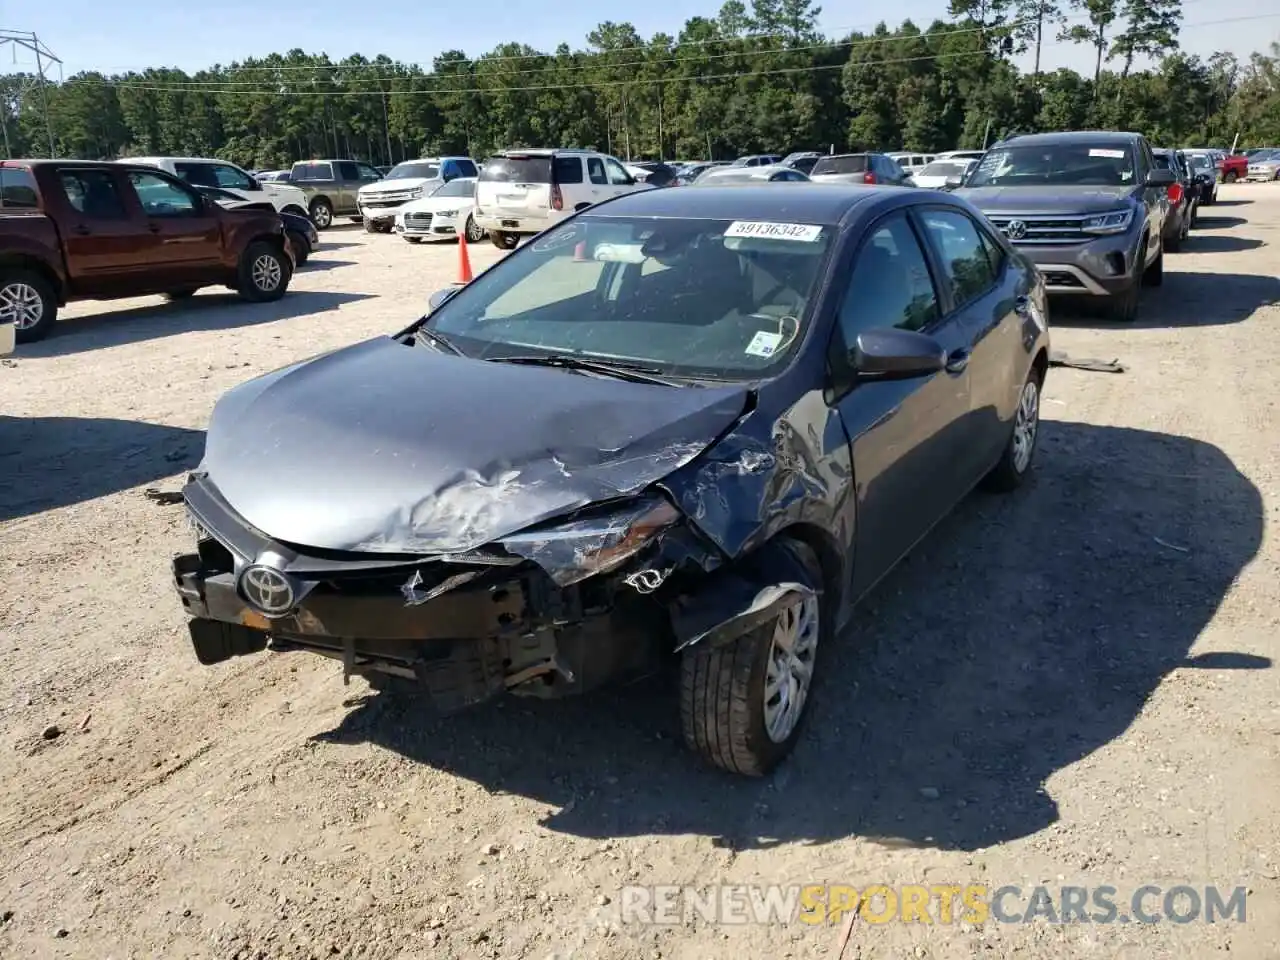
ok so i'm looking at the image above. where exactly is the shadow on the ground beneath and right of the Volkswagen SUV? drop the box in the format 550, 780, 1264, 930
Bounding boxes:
1051, 271, 1280, 330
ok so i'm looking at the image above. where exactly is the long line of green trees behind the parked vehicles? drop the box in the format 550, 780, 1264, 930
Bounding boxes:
0, 0, 1280, 168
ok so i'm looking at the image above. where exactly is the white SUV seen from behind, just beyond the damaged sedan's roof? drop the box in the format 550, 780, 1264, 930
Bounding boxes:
475, 150, 657, 250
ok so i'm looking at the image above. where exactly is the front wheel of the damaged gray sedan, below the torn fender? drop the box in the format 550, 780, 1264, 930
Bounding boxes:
680, 541, 829, 777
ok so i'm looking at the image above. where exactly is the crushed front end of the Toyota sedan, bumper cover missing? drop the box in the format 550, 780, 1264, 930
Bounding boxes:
173, 475, 721, 712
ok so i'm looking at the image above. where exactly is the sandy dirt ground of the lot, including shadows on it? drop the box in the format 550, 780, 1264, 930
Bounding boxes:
0, 192, 1280, 960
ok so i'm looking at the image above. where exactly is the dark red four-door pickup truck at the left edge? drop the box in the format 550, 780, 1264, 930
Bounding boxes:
0, 160, 293, 343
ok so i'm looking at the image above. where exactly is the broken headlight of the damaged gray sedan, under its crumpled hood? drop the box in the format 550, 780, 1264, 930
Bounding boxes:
499, 495, 680, 586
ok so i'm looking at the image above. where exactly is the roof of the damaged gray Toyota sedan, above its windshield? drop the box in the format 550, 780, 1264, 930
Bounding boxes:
582, 183, 890, 225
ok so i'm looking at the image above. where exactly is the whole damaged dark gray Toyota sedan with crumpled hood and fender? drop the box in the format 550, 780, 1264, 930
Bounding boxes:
173, 184, 1048, 774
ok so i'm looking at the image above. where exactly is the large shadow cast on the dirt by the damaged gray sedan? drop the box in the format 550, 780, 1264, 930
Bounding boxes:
309, 421, 1271, 850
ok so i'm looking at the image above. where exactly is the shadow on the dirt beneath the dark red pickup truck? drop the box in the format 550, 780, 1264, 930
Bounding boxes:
15, 291, 372, 360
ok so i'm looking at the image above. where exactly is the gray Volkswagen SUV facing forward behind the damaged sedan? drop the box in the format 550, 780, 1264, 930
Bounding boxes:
957, 131, 1178, 321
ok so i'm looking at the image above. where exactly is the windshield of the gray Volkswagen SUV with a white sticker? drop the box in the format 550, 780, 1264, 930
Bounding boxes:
965, 142, 1134, 187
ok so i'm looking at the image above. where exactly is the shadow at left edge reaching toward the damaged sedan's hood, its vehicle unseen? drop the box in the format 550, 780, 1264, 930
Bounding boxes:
0, 416, 205, 521
